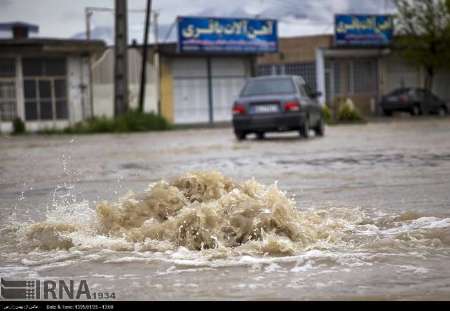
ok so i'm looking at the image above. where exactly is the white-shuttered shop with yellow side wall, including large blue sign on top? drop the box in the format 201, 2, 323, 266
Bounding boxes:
158, 17, 278, 124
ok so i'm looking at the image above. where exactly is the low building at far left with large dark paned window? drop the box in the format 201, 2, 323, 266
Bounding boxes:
0, 22, 105, 132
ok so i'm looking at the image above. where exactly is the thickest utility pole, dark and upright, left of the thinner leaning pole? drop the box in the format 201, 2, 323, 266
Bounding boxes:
114, 0, 128, 117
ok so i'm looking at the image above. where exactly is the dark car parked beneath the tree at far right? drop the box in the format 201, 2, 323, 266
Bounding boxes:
380, 88, 448, 116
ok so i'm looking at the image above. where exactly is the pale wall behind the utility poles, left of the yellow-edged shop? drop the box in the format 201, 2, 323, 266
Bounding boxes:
92, 48, 158, 117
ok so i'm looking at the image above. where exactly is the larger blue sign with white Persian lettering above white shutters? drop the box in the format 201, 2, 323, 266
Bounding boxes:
178, 17, 278, 53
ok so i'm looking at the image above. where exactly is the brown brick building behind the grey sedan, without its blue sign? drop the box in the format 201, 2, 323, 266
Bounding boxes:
257, 15, 450, 115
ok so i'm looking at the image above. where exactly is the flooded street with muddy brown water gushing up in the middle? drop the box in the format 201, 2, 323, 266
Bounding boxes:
0, 118, 450, 300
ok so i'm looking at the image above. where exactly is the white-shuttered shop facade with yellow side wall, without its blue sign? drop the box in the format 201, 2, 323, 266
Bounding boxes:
150, 44, 255, 124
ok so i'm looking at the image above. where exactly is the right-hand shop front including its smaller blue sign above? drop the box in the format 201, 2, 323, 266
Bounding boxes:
316, 15, 394, 115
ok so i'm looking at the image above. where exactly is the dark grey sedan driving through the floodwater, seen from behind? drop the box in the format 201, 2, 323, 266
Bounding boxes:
233, 76, 325, 140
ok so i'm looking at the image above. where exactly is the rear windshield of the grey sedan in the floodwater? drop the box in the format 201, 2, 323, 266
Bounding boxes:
241, 78, 295, 96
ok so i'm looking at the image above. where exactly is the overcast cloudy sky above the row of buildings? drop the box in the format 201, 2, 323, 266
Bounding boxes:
0, 0, 393, 43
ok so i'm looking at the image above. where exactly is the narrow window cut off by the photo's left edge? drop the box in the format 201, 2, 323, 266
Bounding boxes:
0, 58, 17, 121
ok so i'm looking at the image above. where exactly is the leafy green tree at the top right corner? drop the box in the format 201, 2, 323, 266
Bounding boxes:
394, 0, 450, 90
